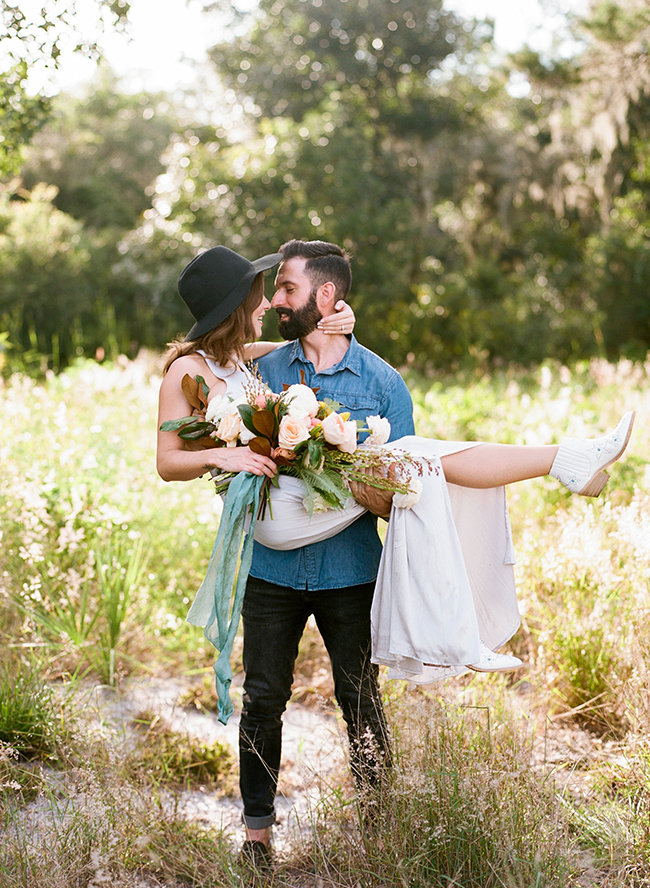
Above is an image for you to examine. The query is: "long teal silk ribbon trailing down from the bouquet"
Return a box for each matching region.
[187,472,264,725]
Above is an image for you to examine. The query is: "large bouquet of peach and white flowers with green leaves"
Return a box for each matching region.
[160,374,422,516]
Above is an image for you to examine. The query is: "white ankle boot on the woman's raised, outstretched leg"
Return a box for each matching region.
[549,411,634,496]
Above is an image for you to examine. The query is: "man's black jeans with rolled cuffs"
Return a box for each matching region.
[239,577,390,829]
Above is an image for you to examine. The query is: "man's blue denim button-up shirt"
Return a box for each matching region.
[250,337,414,590]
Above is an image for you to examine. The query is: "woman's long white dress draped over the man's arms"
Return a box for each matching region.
[196,356,520,683]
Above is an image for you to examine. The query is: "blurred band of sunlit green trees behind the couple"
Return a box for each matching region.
[0,0,650,371]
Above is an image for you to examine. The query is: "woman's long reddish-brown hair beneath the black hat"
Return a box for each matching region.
[163,273,264,376]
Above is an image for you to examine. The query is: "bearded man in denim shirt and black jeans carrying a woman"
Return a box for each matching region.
[239,240,414,865]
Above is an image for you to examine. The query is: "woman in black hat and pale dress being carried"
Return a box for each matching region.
[157,247,634,681]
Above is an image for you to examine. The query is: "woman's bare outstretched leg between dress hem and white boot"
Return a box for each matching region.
[440,444,558,488]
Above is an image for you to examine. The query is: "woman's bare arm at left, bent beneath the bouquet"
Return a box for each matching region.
[156,356,277,481]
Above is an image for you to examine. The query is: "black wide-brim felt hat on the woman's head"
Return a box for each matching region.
[178,247,282,341]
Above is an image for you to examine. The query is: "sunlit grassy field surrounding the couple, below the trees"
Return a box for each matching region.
[0,353,650,888]
